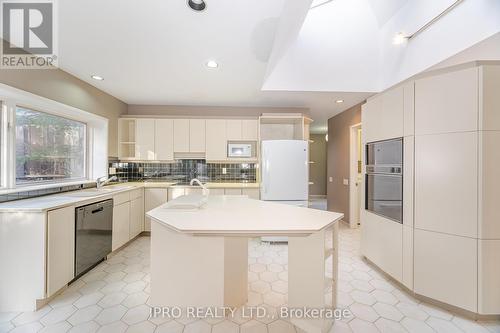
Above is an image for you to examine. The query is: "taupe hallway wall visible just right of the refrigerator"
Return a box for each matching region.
[309,134,326,195]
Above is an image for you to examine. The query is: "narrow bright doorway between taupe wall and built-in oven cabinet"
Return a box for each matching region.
[349,123,363,228]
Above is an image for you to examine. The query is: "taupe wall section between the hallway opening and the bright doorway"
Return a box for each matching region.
[327,104,361,222]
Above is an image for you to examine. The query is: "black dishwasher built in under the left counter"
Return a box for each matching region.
[75,199,113,279]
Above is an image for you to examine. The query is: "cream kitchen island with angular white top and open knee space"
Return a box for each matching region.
[147,195,343,332]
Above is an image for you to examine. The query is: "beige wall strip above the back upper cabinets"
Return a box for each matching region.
[128,105,309,117]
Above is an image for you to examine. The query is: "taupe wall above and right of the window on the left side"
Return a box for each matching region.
[0,69,127,156]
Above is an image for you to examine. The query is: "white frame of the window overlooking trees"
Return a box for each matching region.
[13,104,89,188]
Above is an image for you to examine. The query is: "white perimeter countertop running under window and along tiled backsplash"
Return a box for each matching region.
[0,181,259,213]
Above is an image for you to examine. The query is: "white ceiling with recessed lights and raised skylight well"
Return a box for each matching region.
[58,0,500,132]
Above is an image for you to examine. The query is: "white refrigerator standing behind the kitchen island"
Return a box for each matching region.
[260,140,309,242]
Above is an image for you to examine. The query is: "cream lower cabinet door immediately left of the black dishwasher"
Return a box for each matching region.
[46,206,75,296]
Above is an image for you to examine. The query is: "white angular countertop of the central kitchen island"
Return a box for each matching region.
[147,195,344,236]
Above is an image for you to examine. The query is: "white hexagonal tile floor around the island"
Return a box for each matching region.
[0,202,500,333]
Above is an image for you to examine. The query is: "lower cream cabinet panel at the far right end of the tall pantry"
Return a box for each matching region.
[478,239,500,315]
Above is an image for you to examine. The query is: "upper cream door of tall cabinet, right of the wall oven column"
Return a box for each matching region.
[415,67,479,135]
